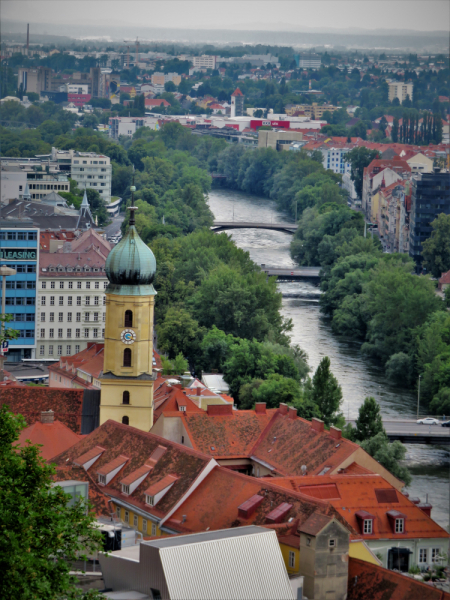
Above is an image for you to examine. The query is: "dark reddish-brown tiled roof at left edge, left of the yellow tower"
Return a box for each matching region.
[0,385,84,433]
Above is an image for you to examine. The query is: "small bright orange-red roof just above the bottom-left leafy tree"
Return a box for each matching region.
[18,421,80,460]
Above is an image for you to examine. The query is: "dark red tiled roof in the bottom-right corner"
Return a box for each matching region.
[347,557,450,600]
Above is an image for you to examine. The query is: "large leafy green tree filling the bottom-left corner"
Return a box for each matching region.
[0,406,101,600]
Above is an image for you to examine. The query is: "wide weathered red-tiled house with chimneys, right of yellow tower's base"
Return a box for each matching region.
[151,403,403,490]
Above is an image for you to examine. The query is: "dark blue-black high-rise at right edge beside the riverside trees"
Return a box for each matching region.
[409,168,450,271]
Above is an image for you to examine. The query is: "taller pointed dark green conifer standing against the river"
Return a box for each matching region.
[311,356,342,426]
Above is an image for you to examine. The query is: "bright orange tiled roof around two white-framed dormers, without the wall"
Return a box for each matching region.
[272,473,448,540]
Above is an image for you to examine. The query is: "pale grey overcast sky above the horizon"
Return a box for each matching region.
[1,0,450,34]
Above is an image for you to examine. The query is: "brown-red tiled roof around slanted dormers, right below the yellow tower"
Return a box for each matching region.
[54,420,211,517]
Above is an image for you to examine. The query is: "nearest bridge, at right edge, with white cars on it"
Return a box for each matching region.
[349,419,450,446]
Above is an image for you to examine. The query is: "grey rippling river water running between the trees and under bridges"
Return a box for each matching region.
[209,190,450,528]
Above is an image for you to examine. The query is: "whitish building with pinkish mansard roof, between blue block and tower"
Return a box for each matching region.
[37,229,111,360]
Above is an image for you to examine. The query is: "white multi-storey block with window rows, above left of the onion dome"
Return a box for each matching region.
[51,148,112,204]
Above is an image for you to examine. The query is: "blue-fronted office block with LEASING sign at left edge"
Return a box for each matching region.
[0,217,39,362]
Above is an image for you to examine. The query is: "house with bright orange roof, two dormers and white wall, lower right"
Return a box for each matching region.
[273,471,448,572]
